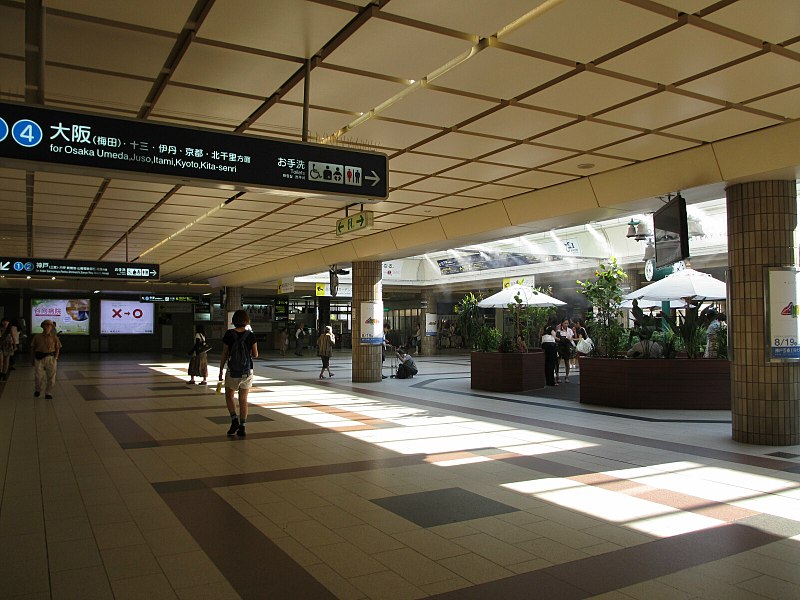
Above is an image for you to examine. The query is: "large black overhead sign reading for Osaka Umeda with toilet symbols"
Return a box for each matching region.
[0,102,389,202]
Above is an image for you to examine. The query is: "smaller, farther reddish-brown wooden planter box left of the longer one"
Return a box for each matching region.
[470,350,545,392]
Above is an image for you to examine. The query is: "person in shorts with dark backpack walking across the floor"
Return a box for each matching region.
[219,309,258,437]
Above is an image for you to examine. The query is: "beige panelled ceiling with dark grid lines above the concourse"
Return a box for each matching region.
[0,0,800,285]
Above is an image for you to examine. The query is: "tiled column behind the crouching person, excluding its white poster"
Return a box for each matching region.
[352,260,383,383]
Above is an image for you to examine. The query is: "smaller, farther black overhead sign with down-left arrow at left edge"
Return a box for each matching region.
[0,256,159,281]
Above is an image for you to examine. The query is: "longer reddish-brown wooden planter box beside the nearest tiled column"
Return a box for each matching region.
[578,357,731,410]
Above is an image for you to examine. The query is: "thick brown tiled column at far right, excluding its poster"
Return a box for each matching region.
[727,181,800,446]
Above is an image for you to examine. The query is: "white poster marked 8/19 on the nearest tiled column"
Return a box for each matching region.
[764,267,800,361]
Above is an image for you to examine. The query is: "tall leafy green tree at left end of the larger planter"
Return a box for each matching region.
[578,256,627,358]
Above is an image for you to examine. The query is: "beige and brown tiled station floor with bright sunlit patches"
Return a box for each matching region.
[0,354,800,600]
